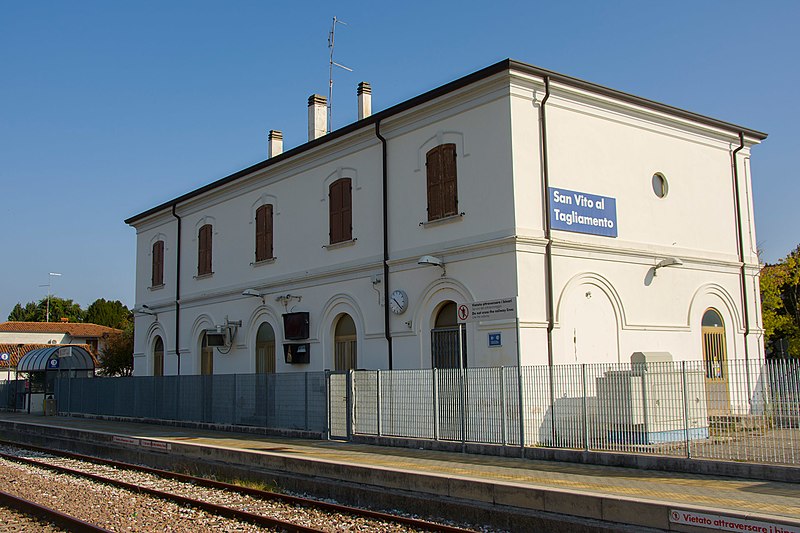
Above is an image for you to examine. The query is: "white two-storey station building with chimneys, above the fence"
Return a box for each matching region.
[126,60,766,375]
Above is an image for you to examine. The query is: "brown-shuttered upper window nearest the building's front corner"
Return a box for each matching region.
[425,143,458,221]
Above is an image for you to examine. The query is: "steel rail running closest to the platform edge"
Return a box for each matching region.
[0,439,470,533]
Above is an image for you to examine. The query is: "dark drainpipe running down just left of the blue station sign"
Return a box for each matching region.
[536,76,556,445]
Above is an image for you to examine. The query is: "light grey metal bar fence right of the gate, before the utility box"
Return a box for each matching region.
[349,360,800,464]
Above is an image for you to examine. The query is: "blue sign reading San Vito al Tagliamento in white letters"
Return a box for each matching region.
[548,187,617,237]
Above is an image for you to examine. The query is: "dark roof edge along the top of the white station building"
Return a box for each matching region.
[125,59,767,224]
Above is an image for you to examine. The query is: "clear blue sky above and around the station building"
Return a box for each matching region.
[0,0,800,320]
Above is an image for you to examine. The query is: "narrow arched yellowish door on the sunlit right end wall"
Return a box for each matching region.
[702,308,730,416]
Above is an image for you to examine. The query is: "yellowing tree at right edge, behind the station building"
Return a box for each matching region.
[761,245,800,357]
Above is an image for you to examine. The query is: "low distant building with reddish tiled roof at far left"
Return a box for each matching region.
[0,322,122,356]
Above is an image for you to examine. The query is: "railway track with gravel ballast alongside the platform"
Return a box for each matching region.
[0,441,470,533]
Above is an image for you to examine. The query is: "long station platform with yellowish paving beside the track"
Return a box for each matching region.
[0,412,800,533]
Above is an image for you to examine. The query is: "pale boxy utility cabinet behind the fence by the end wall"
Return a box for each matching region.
[597,352,708,444]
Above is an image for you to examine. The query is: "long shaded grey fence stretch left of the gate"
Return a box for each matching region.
[56,372,328,433]
